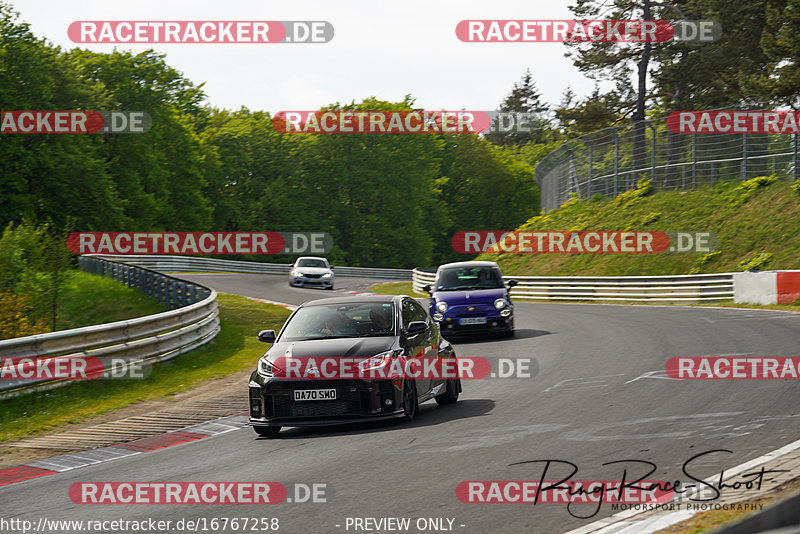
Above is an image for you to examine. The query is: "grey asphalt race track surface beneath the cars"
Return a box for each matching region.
[6,274,800,534]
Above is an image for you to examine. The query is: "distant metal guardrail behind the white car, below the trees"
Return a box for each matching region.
[92,254,411,280]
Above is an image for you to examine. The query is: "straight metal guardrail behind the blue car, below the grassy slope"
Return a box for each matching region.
[412,269,733,302]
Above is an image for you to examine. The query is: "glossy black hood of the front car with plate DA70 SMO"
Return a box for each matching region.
[266,336,396,362]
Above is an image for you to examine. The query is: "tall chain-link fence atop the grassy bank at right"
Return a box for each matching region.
[536,116,800,210]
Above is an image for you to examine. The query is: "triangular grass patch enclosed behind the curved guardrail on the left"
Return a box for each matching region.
[56,271,167,330]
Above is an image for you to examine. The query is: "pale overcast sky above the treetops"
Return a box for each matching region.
[11,0,594,113]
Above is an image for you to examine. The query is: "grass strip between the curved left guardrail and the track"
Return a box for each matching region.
[0,294,290,442]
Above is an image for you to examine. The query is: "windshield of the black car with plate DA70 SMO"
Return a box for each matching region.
[281,302,395,341]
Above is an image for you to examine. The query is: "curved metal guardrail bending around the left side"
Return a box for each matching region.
[0,256,220,397]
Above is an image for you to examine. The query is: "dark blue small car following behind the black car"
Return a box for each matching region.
[422,261,517,337]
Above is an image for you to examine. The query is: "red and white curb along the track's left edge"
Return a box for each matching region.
[0,415,247,486]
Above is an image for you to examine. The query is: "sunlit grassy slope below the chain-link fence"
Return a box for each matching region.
[478,179,800,276]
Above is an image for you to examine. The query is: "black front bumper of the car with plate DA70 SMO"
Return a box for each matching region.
[249,376,403,426]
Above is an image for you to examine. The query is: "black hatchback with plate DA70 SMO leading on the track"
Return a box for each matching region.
[250,295,461,436]
